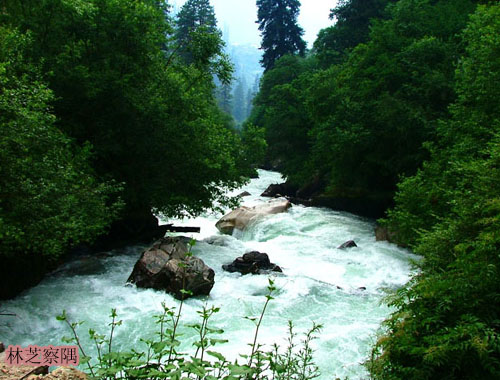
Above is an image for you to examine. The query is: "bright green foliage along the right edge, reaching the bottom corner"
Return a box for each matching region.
[368,3,500,380]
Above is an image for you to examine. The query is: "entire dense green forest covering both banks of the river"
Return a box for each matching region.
[0,0,500,380]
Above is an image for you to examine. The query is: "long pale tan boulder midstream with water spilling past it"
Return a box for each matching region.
[215,198,291,235]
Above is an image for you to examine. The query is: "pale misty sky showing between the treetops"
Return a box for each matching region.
[171,0,337,47]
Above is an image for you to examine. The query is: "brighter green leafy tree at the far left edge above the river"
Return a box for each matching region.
[0,27,120,299]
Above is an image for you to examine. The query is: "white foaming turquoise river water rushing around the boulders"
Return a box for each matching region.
[0,171,415,379]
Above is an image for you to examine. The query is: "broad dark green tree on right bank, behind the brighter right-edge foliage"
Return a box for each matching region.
[308,0,476,208]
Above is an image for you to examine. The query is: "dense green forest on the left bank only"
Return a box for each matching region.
[0,0,262,297]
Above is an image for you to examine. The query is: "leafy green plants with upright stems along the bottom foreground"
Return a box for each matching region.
[57,279,321,380]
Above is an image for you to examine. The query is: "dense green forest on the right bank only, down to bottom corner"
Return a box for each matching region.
[249,0,500,380]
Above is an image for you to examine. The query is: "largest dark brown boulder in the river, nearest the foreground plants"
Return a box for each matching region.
[127,237,215,299]
